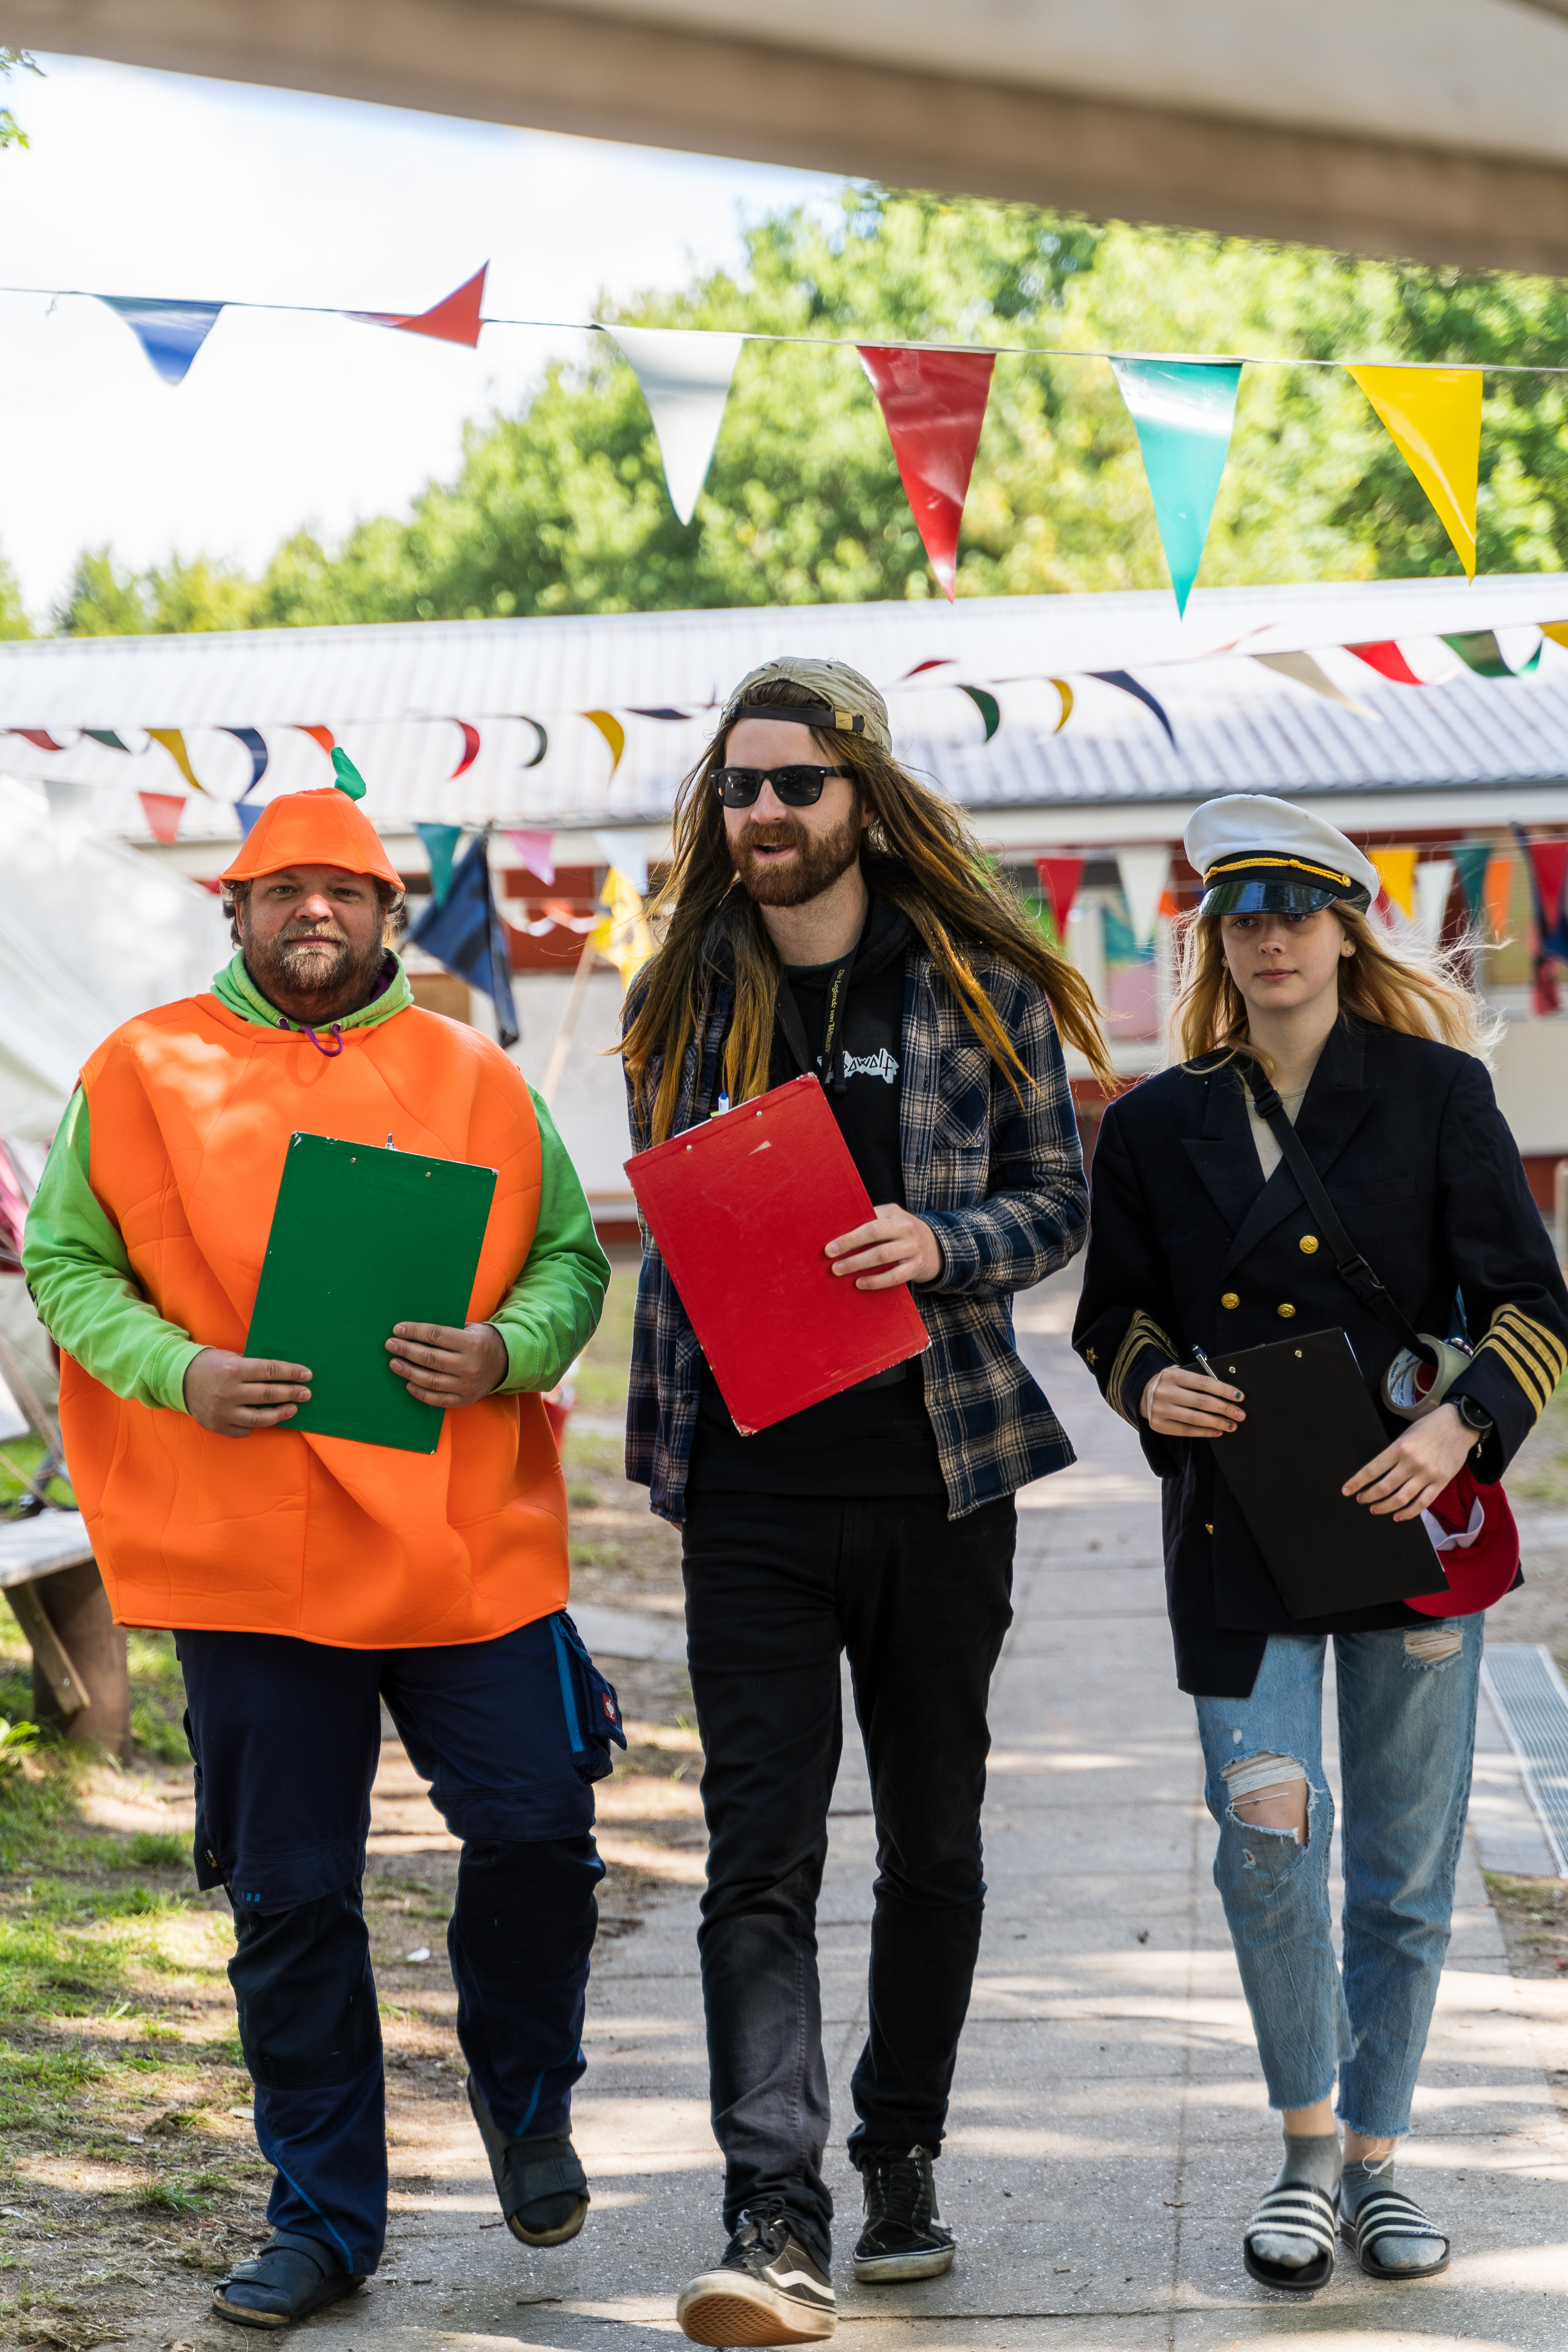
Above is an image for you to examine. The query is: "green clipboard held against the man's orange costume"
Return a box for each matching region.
[244,1134,496,1453]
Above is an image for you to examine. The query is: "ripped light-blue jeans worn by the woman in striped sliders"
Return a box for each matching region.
[1196,1616,1486,2140]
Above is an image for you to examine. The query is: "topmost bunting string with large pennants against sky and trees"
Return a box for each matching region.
[0,263,1568,614]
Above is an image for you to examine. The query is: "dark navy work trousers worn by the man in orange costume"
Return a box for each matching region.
[176,1618,618,2272]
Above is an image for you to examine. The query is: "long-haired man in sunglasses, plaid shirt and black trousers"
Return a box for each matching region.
[623,661,1105,2345]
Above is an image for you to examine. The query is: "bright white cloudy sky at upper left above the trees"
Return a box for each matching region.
[0,56,837,616]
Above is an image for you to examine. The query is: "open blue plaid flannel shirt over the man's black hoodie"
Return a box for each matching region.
[625,927,1088,1526]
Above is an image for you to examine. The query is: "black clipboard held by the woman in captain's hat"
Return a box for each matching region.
[1208,1331,1448,1618]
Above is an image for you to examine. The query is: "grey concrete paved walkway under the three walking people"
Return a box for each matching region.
[355,1287,1568,2352]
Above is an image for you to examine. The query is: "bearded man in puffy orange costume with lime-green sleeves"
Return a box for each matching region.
[23,755,620,2329]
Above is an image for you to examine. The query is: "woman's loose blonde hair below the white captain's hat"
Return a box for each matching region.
[1171,903,1498,1077]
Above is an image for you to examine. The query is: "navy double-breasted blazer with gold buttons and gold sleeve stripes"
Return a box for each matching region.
[1072,1016,1568,1698]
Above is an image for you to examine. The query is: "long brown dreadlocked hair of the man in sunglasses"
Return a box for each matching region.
[620,677,1117,1143]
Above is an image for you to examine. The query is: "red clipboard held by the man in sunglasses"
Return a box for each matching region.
[625,1077,931,1437]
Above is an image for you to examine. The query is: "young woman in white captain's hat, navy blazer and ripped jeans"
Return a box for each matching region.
[1074,795,1568,2293]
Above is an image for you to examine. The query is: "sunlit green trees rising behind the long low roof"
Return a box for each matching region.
[61,188,1568,628]
